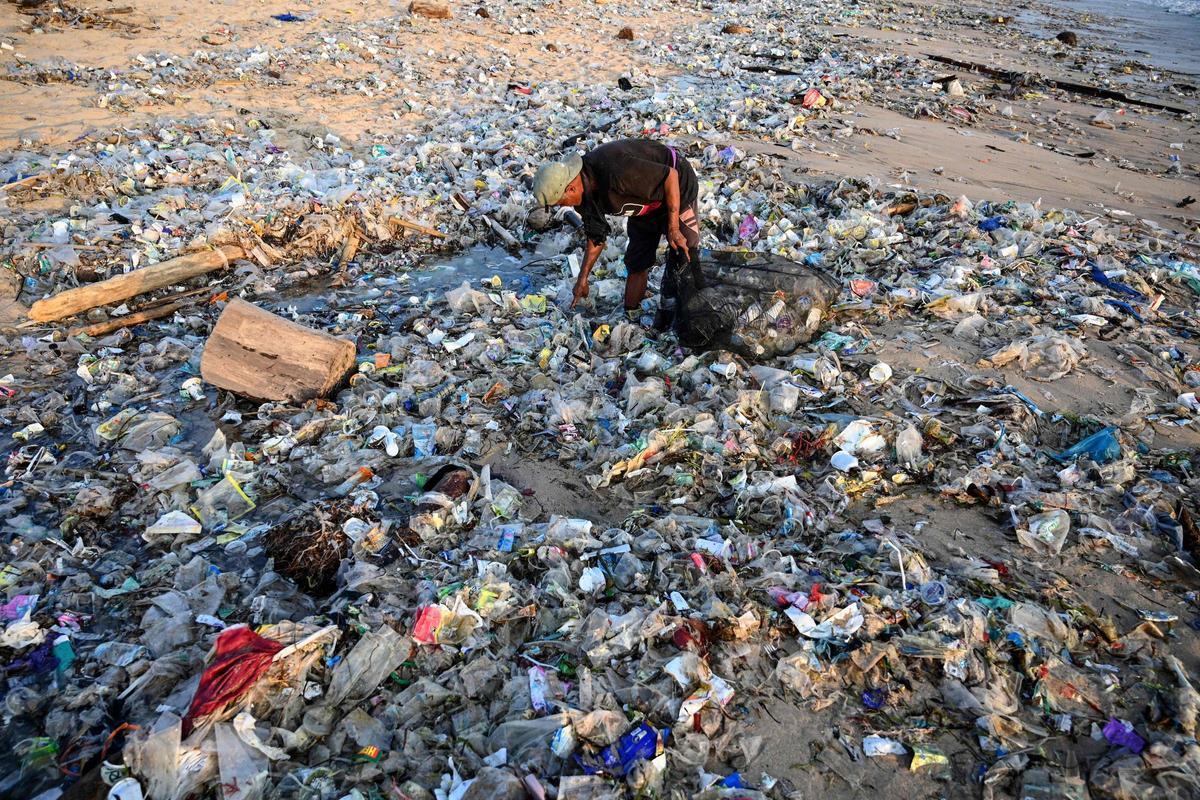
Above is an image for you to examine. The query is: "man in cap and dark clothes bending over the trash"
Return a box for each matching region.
[533,139,700,327]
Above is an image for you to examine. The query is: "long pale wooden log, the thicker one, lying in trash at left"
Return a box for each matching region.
[29,245,246,323]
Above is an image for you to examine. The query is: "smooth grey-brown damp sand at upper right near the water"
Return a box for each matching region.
[772,2,1200,234]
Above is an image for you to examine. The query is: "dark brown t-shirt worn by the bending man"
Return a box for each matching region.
[578,139,697,245]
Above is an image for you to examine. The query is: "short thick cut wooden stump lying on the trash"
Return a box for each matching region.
[200,299,354,402]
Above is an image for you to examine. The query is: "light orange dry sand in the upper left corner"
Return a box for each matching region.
[0,0,665,149]
